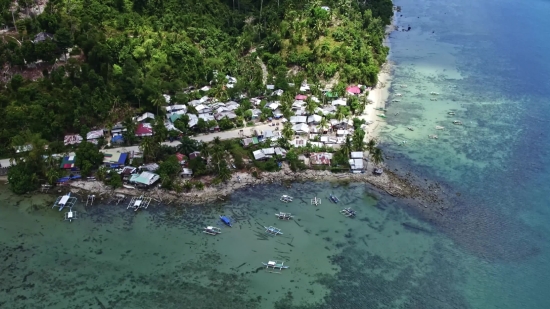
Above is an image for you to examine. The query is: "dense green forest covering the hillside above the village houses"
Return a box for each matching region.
[0,0,393,153]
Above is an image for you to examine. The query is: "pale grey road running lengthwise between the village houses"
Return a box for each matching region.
[0,123,281,167]
